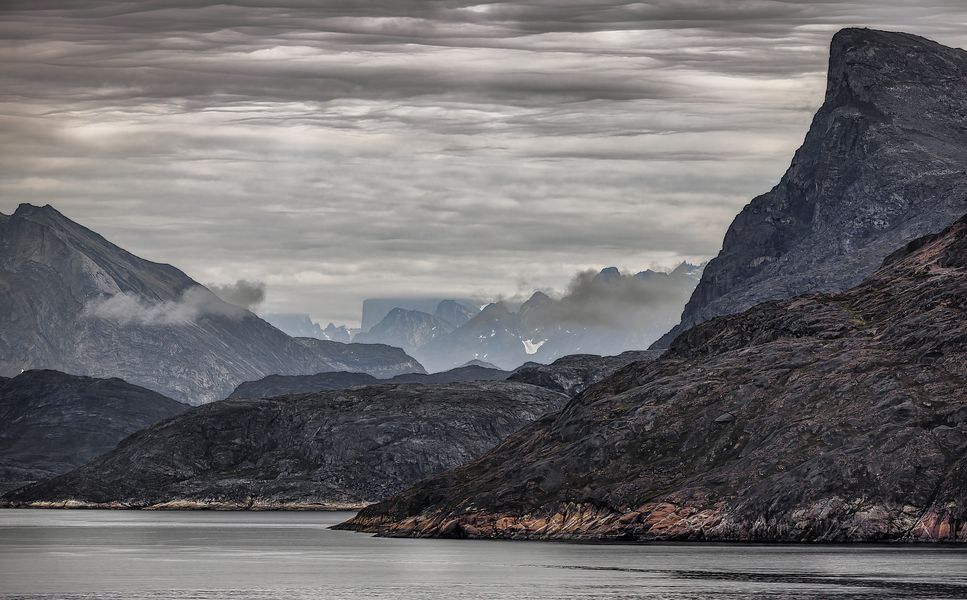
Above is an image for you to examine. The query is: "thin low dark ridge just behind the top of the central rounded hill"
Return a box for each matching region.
[228,365,516,400]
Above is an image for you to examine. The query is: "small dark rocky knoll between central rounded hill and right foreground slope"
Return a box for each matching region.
[507,350,662,397]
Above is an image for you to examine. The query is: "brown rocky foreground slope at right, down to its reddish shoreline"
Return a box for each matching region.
[345,217,967,542]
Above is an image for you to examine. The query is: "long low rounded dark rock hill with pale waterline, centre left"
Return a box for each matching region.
[4,382,567,508]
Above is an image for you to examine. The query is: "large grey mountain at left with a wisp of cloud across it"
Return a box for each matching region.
[0,204,423,404]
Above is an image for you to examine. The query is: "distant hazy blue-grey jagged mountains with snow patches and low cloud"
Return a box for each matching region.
[263,263,704,372]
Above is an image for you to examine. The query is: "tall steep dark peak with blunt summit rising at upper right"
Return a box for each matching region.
[656,29,967,347]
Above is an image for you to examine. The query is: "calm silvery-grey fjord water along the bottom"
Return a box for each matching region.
[0,510,967,600]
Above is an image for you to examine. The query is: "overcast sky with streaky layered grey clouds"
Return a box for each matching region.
[0,0,967,325]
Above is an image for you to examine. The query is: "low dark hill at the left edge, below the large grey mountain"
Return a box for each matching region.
[0,371,188,491]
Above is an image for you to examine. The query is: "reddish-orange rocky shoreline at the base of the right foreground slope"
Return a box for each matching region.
[342,499,967,544]
